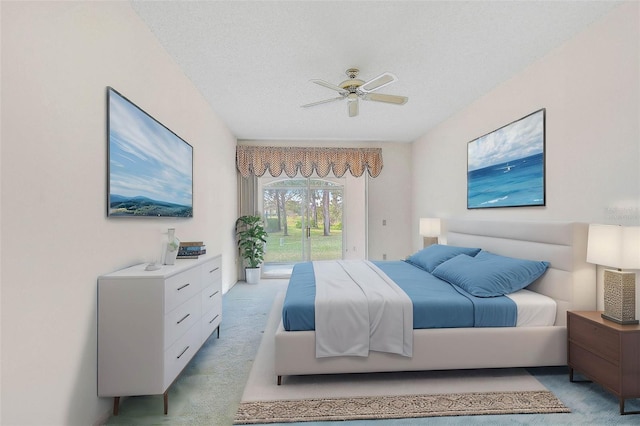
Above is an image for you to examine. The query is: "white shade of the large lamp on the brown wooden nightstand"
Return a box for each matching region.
[587,225,640,269]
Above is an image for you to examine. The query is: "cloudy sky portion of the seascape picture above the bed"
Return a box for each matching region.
[467,110,544,171]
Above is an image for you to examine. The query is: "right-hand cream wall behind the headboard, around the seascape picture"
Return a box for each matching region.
[412,2,640,314]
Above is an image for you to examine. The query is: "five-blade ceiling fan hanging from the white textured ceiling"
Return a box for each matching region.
[302,68,409,117]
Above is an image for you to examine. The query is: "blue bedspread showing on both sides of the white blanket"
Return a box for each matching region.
[282,261,517,331]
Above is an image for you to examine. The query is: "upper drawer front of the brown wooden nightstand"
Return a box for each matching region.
[569,315,620,364]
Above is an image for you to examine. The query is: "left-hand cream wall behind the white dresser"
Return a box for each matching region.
[0,2,237,425]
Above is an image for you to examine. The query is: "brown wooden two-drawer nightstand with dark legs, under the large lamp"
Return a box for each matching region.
[567,311,640,414]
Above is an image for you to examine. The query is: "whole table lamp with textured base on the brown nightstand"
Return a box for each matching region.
[587,225,640,324]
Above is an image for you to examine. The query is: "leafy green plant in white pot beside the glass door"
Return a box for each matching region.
[236,215,268,284]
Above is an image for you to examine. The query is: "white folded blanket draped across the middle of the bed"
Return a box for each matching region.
[313,260,413,358]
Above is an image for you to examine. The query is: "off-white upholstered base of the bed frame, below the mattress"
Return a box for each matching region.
[275,324,567,385]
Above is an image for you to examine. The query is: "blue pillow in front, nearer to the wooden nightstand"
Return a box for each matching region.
[433,250,549,297]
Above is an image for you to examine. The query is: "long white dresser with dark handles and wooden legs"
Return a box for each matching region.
[98,255,222,415]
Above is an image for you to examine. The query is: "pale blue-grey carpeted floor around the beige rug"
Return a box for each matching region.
[106,280,640,426]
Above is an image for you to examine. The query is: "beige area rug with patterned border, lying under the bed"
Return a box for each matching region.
[234,295,570,424]
